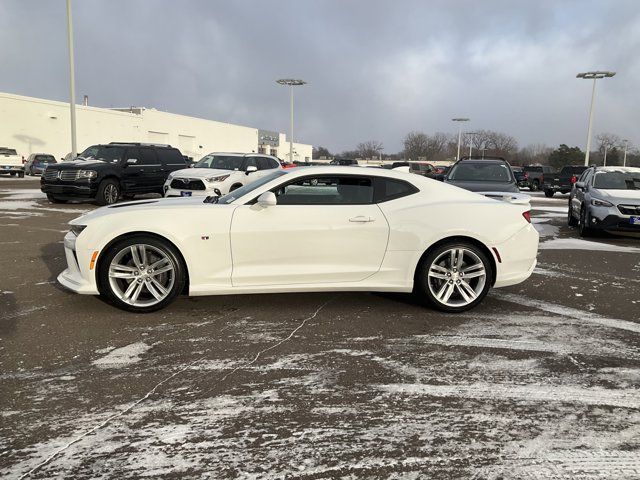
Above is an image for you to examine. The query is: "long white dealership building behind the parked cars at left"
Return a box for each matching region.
[0,92,312,162]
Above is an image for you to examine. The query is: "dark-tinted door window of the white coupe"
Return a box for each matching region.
[274,176,373,205]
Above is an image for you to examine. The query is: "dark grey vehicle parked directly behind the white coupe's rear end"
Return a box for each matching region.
[444,157,520,193]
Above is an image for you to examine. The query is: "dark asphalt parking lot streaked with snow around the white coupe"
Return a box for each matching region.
[0,178,640,479]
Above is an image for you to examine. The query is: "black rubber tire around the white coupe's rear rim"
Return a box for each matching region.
[414,241,493,313]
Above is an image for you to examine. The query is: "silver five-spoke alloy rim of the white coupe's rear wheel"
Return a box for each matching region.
[427,247,487,307]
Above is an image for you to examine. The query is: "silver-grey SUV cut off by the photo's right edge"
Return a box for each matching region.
[567,167,640,237]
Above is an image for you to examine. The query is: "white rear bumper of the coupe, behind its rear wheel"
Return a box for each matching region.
[494,224,539,288]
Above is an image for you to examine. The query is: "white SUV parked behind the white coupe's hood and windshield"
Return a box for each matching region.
[164,153,282,197]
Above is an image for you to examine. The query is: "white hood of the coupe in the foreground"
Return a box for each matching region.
[69,197,225,225]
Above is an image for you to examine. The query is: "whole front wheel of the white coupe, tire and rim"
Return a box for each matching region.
[98,235,186,313]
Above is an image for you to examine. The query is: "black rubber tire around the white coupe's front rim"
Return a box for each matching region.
[98,235,187,313]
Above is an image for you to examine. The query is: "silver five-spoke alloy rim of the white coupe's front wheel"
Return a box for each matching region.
[109,244,176,307]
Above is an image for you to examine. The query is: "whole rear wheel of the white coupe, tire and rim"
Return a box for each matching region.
[416,242,493,313]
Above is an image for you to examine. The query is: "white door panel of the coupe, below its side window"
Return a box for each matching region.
[231,204,389,286]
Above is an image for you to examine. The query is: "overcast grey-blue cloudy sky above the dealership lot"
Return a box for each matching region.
[0,0,640,153]
